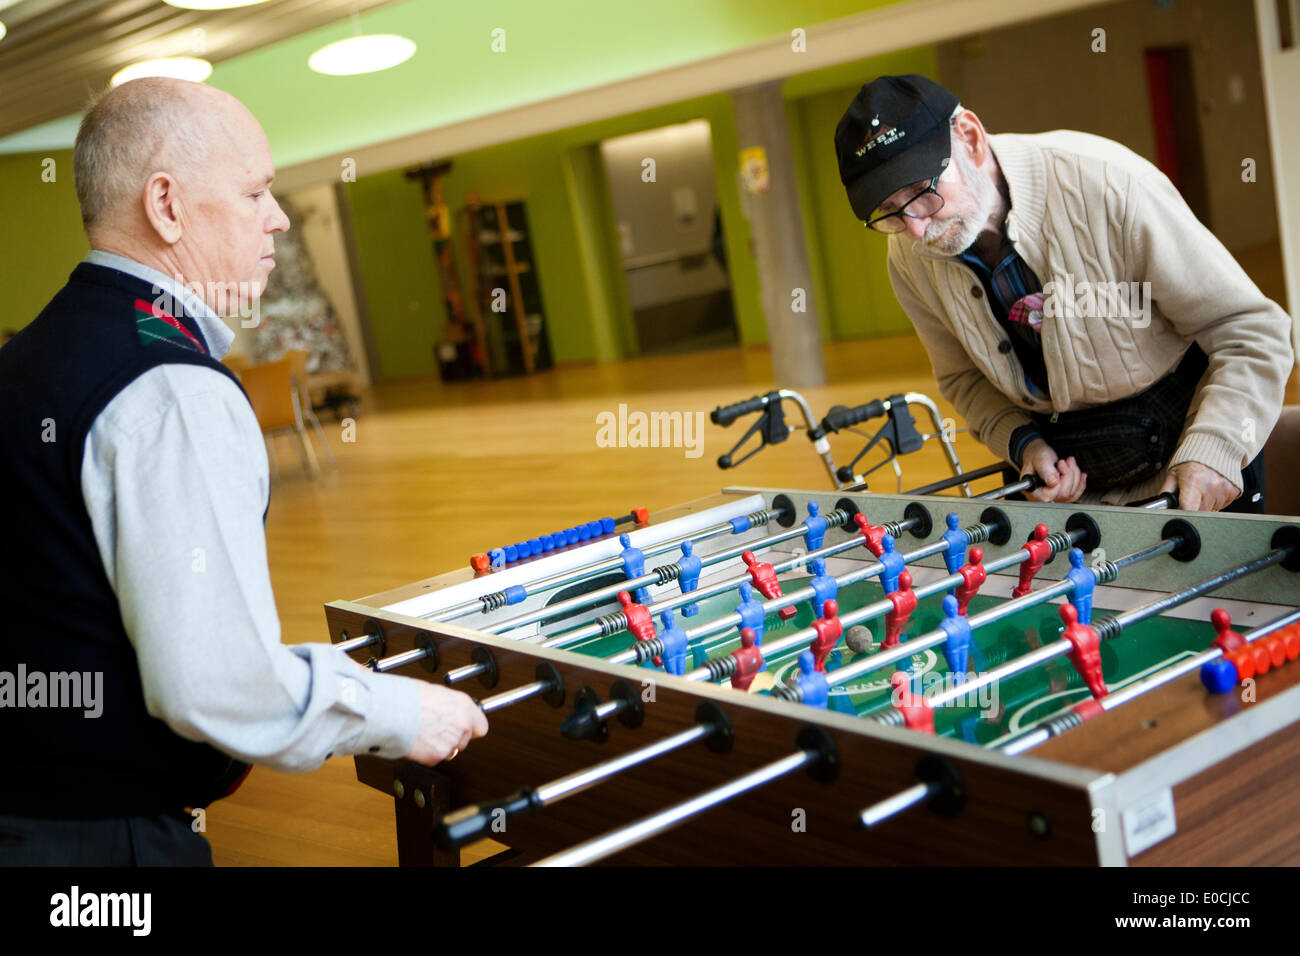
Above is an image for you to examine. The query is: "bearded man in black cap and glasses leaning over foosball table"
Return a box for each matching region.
[835,75,1294,511]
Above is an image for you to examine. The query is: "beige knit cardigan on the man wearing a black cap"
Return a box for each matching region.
[888,130,1294,503]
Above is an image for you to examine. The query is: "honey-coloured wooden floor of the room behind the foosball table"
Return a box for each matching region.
[207,336,1300,865]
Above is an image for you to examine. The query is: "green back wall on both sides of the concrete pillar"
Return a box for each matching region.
[351,47,933,377]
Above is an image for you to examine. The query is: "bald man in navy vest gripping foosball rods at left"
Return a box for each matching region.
[0,79,488,865]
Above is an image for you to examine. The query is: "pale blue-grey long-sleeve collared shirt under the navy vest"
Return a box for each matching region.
[82,250,420,771]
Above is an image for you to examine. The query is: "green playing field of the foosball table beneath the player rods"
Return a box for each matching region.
[543,578,1214,744]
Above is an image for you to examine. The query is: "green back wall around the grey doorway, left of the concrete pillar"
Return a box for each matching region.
[351,94,767,377]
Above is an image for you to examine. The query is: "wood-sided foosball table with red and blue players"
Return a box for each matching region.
[325,488,1300,866]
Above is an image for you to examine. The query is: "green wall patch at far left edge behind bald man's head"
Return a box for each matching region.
[0,150,90,329]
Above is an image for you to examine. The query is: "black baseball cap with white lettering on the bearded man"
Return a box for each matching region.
[835,73,959,221]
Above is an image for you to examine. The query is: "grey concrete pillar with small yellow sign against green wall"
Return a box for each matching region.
[732,81,826,389]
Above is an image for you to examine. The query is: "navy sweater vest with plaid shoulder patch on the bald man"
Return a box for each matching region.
[0,263,256,818]
